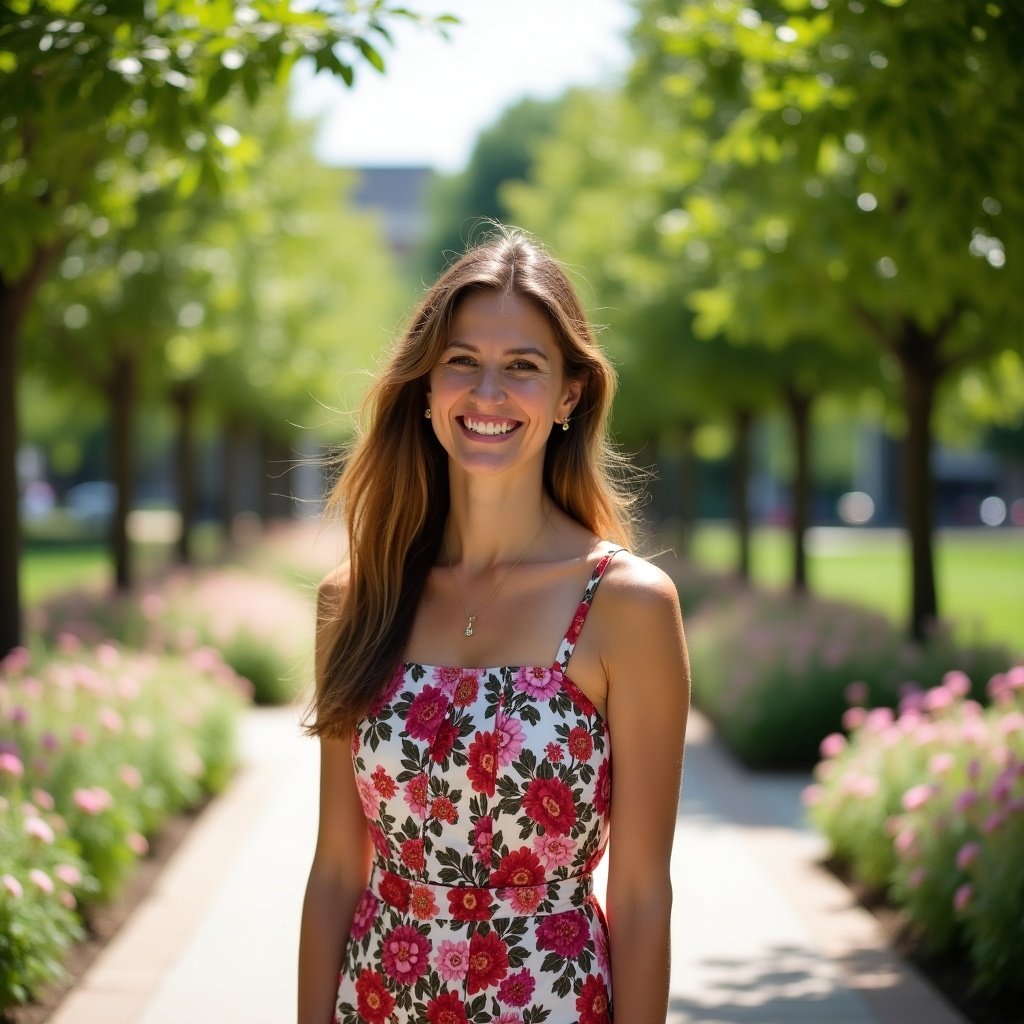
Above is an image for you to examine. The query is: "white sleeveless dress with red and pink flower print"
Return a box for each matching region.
[335,548,621,1024]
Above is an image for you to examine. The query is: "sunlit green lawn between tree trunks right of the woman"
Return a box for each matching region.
[693,523,1024,652]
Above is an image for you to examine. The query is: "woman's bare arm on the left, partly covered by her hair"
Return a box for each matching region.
[298,578,373,1024]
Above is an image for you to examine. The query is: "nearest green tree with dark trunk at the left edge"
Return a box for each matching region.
[0,0,440,650]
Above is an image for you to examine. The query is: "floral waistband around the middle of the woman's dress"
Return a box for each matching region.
[370,861,594,921]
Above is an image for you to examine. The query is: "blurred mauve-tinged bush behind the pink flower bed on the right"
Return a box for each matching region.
[687,591,1012,768]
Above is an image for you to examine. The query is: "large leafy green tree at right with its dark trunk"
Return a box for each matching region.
[635,0,1024,638]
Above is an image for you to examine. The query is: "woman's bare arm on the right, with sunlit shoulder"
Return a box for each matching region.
[601,556,690,1024]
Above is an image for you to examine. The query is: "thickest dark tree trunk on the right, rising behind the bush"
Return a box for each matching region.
[898,323,940,641]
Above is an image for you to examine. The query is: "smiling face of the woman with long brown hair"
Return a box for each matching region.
[428,291,581,474]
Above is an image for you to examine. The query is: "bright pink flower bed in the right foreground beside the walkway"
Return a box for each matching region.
[805,666,1024,993]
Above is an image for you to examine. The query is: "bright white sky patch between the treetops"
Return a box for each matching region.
[293,0,633,173]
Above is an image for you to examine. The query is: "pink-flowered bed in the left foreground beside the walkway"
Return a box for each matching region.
[0,635,251,1012]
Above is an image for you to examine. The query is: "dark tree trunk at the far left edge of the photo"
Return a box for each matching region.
[0,246,60,657]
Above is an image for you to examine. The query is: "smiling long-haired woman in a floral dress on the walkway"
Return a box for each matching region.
[299,230,689,1024]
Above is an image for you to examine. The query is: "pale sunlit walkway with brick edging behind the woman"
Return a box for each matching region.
[44,709,964,1024]
